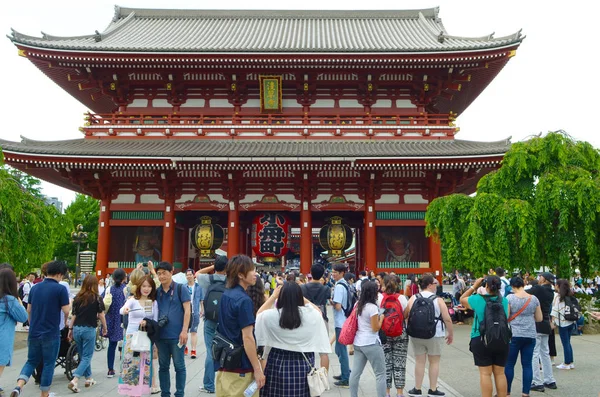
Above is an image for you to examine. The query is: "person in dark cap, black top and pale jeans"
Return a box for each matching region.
[526,272,556,392]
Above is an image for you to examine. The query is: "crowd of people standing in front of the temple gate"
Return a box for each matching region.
[0,255,600,397]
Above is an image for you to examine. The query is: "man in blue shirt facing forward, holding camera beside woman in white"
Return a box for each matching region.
[155,262,191,397]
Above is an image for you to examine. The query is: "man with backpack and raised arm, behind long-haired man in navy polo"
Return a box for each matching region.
[196,255,227,394]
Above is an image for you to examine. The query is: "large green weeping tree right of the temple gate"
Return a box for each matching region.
[425,131,600,277]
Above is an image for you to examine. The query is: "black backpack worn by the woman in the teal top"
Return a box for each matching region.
[479,296,512,352]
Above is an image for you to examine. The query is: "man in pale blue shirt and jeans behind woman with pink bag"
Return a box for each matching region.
[331,263,350,388]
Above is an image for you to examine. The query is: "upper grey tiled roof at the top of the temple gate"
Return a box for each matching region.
[10,7,523,53]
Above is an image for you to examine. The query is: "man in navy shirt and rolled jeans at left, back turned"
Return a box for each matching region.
[10,261,70,397]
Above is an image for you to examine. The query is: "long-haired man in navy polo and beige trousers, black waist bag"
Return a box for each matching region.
[215,255,265,397]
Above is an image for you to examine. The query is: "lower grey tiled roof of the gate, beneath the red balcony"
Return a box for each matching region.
[0,138,510,161]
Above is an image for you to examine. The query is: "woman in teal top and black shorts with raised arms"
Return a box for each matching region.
[460,276,509,397]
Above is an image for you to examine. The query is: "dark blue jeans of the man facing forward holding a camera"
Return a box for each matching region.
[156,339,186,397]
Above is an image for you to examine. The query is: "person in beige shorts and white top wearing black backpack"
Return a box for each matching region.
[404,274,454,397]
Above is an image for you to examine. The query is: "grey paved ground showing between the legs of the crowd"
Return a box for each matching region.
[5,296,600,397]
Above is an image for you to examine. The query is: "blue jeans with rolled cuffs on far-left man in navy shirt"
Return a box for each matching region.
[18,338,60,391]
